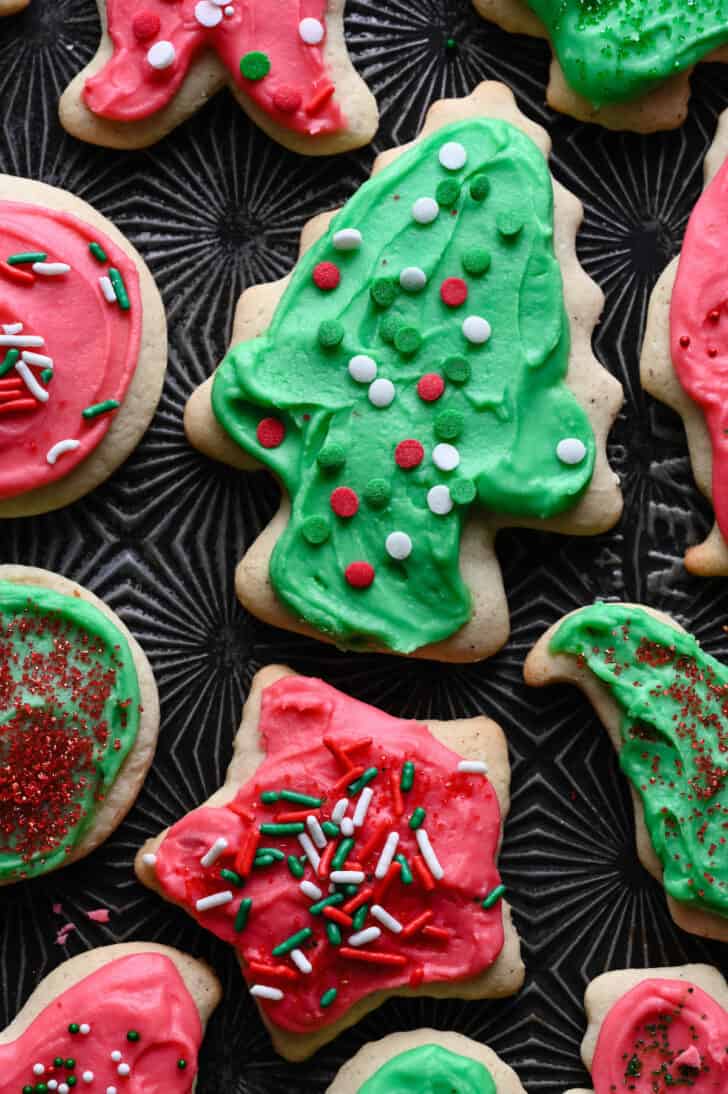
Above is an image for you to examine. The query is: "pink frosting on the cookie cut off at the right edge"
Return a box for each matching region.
[670,161,728,540]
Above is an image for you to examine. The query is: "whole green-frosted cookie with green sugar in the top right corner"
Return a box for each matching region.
[474,0,728,132]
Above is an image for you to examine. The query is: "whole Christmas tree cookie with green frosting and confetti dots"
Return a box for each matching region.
[186,84,621,661]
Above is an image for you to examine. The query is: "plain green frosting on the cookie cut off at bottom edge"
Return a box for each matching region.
[359,1045,496,1094]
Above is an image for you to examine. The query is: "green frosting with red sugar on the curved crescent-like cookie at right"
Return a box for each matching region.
[550,604,728,916]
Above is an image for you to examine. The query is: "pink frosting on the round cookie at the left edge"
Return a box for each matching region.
[0,201,141,498]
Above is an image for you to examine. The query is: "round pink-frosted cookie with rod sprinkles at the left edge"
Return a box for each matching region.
[0,175,166,517]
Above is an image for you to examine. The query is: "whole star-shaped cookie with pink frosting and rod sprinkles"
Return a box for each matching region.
[136,666,523,1060]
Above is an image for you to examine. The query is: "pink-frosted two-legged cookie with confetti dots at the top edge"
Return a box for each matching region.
[60,0,378,155]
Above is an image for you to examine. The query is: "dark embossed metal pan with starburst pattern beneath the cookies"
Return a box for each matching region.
[0,0,728,1094]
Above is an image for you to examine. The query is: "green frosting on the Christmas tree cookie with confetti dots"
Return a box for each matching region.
[212,118,594,653]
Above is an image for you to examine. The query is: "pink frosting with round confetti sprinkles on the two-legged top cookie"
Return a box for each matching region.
[83,0,346,137]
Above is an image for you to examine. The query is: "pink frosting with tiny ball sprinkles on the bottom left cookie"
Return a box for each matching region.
[0,953,203,1094]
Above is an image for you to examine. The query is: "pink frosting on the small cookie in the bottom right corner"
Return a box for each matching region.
[591,978,728,1094]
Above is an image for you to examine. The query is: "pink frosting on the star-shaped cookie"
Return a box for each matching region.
[157,677,504,1033]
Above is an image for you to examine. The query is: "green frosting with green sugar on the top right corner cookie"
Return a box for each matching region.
[527,0,728,106]
